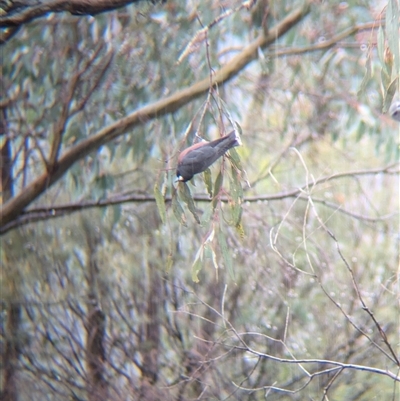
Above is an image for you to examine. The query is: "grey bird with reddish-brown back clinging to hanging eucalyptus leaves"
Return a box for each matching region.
[176,131,242,182]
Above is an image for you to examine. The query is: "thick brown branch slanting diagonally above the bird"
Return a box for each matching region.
[0,1,310,227]
